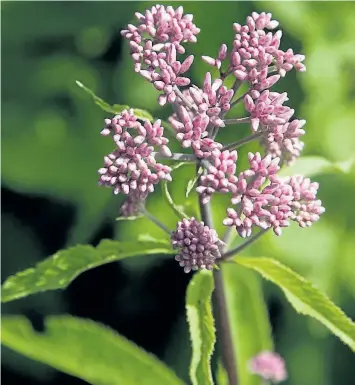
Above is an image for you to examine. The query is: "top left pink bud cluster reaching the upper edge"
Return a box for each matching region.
[121,5,200,106]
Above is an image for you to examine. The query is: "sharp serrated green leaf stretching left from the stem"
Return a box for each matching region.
[1,240,172,302]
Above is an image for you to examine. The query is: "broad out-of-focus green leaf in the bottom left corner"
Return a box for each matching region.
[1,316,183,385]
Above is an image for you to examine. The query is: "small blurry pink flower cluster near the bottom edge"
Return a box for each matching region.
[249,352,287,384]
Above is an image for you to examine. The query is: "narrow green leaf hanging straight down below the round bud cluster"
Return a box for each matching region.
[186,270,216,385]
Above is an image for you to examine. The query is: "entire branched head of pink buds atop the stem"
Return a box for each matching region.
[99,5,324,272]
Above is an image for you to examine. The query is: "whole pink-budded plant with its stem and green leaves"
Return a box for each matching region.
[2,5,355,385]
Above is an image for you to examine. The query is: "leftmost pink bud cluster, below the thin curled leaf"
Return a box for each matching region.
[99,110,171,198]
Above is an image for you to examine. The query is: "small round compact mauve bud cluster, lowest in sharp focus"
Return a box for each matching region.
[171,217,223,273]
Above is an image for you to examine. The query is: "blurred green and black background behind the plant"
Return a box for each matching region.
[1,1,355,385]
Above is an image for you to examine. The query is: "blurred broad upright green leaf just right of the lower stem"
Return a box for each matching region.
[221,263,273,385]
